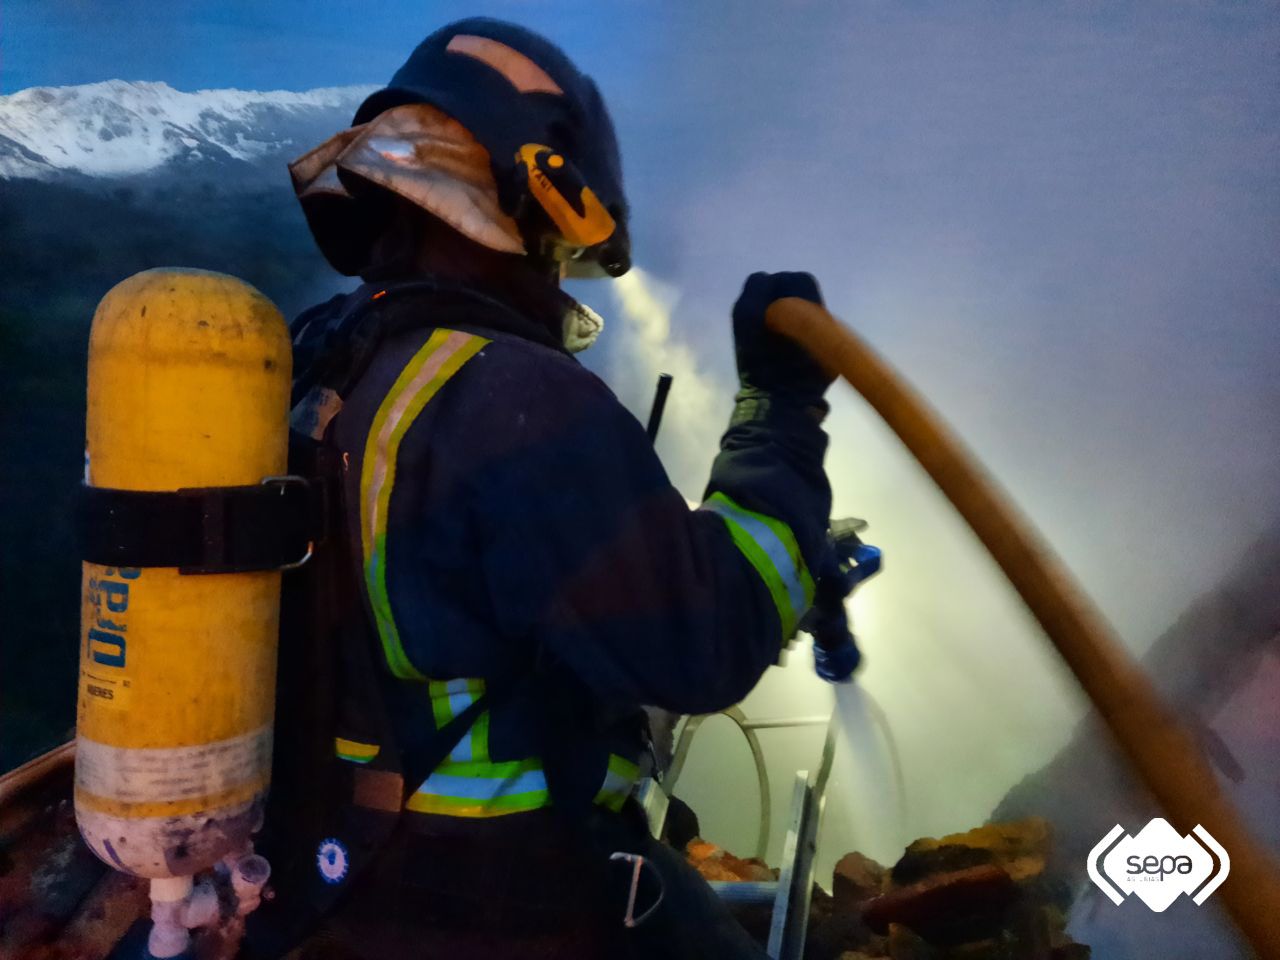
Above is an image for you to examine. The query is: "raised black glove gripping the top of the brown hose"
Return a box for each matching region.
[733,273,833,406]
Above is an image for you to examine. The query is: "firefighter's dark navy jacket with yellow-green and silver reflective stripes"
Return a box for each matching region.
[286,277,831,822]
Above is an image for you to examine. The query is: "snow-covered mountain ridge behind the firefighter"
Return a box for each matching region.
[0,81,374,179]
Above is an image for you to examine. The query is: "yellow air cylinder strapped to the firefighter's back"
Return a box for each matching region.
[76,269,291,897]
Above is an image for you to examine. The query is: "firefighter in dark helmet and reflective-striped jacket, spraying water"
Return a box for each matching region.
[268,19,831,957]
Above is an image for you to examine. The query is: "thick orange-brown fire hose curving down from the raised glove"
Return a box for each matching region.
[765,297,1280,957]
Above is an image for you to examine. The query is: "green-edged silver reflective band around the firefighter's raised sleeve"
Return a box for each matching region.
[700,493,814,643]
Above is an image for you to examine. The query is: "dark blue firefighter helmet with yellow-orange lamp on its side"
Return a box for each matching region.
[352,17,631,276]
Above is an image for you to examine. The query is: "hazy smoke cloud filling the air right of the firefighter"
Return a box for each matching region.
[588,9,1280,916]
